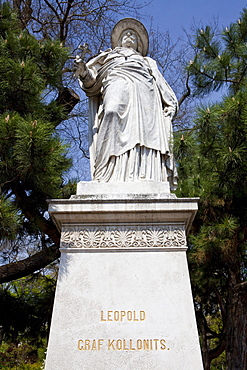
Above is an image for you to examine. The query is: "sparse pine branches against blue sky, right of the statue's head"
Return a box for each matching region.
[188,9,247,96]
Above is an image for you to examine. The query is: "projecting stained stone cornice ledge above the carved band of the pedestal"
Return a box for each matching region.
[48,194,198,232]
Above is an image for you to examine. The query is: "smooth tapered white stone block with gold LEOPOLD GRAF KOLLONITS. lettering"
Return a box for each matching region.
[46,251,202,370]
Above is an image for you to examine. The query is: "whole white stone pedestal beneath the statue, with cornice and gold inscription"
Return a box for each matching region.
[45,183,203,370]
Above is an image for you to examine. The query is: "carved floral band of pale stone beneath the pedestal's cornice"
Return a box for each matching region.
[61,225,186,248]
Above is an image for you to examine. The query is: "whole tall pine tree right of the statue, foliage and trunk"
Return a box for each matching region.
[177,9,247,370]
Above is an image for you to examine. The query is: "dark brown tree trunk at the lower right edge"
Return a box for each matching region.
[226,277,247,370]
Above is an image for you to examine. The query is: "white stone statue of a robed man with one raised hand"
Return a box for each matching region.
[76,18,178,190]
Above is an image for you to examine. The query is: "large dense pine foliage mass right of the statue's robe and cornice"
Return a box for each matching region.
[177,91,247,284]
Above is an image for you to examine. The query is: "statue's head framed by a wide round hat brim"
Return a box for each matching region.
[111,18,148,56]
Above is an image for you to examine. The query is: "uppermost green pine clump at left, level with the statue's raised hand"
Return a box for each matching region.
[0,3,68,116]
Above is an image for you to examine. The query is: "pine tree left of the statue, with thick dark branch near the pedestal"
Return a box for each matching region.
[0,3,78,282]
